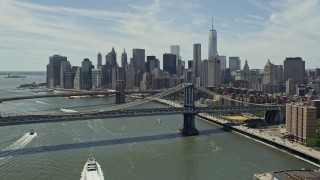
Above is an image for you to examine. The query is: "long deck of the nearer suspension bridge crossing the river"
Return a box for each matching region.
[0,106,278,126]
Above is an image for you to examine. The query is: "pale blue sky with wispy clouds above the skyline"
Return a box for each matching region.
[0,0,320,71]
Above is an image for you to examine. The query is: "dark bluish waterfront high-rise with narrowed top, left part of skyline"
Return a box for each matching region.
[81,58,92,90]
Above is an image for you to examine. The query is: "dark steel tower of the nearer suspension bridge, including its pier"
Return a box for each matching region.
[182,83,199,136]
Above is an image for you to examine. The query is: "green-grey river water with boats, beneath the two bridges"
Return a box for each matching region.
[0,75,316,180]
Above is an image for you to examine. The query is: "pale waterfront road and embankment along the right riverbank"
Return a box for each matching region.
[156,98,320,168]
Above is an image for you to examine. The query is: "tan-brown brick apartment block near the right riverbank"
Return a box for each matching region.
[286,104,317,142]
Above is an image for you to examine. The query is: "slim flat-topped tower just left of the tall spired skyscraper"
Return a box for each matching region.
[192,44,201,84]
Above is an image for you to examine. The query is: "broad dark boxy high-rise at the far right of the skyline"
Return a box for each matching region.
[283,57,305,84]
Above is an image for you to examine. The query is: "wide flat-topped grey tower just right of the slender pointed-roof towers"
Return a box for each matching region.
[130,49,146,72]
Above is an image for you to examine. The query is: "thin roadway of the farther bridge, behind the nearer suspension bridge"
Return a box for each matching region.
[0,90,161,103]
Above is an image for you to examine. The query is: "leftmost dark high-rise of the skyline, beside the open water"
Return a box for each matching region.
[47,55,67,88]
